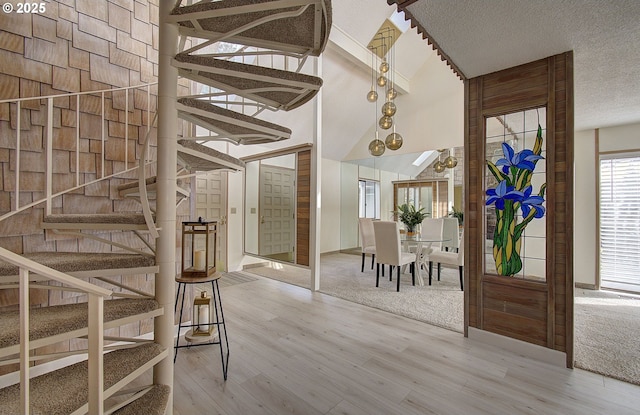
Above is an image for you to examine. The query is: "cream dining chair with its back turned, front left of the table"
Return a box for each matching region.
[373,221,416,291]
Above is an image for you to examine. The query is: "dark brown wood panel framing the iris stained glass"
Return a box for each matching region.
[465,52,573,367]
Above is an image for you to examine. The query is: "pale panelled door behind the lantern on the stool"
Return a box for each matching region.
[195,172,228,271]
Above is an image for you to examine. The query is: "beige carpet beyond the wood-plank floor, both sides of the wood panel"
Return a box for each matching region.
[246,254,640,385]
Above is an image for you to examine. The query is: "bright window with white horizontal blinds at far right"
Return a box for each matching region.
[600,153,640,292]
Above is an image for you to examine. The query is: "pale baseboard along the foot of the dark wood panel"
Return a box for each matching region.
[468,327,567,367]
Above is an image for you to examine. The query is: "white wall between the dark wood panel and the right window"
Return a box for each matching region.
[573,124,640,287]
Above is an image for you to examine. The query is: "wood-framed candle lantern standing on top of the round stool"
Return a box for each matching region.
[182,218,218,278]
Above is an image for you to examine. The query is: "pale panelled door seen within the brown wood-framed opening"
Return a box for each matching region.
[259,164,296,261]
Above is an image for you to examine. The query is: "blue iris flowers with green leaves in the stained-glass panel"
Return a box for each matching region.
[486,125,547,276]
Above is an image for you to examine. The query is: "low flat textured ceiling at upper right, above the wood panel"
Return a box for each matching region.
[407,0,640,130]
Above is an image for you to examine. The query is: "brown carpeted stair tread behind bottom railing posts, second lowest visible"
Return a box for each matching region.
[0,343,163,415]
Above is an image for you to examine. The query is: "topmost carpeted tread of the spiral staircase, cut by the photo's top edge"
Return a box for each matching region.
[171,0,332,56]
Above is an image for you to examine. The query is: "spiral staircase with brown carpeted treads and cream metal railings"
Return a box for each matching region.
[0,0,331,414]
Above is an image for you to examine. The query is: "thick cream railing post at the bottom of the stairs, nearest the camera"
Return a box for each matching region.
[88,294,104,415]
